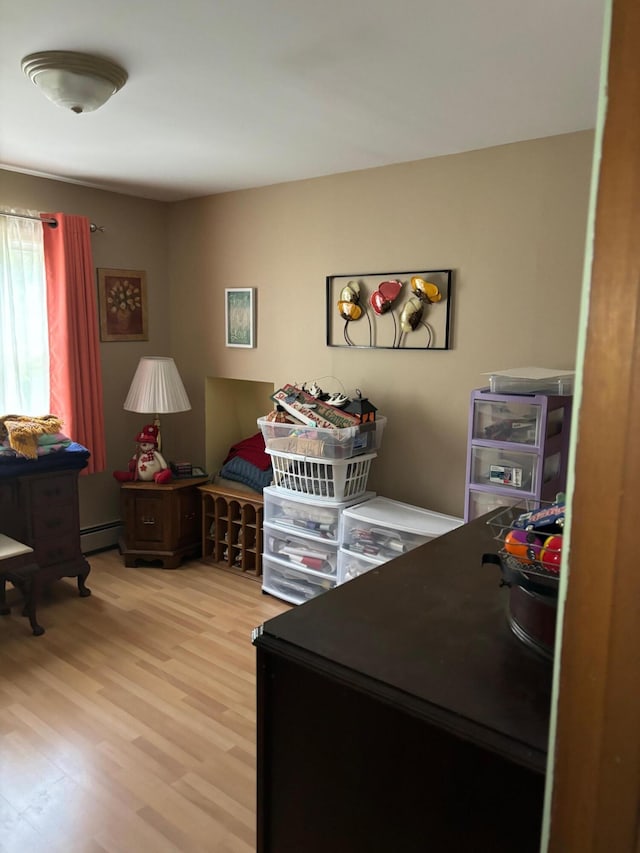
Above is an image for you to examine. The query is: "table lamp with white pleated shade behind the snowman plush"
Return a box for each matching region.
[124,355,191,451]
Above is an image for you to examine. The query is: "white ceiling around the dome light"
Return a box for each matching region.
[0,0,604,201]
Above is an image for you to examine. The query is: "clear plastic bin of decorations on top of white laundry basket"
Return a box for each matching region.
[258,416,387,459]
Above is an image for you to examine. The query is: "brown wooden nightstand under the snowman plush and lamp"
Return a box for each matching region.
[119,477,208,569]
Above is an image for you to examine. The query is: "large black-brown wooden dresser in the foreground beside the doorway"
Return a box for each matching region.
[254,516,552,853]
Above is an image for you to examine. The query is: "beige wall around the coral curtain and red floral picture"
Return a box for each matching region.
[0,171,170,528]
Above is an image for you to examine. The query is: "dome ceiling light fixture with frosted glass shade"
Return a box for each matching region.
[22,50,128,113]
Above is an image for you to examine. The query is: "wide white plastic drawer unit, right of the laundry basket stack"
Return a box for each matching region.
[338,497,463,583]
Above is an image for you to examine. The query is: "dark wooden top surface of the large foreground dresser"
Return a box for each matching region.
[256,516,552,773]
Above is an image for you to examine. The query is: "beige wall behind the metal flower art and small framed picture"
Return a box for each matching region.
[170,131,593,515]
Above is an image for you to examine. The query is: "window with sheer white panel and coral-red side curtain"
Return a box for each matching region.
[0,210,106,473]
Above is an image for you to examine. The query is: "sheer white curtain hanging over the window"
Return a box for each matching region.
[0,208,49,416]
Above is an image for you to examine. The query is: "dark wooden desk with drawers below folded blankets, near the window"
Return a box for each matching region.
[0,445,91,597]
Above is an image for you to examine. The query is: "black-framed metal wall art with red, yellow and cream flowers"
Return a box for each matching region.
[327,270,452,350]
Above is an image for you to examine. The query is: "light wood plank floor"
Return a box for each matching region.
[0,550,289,853]
